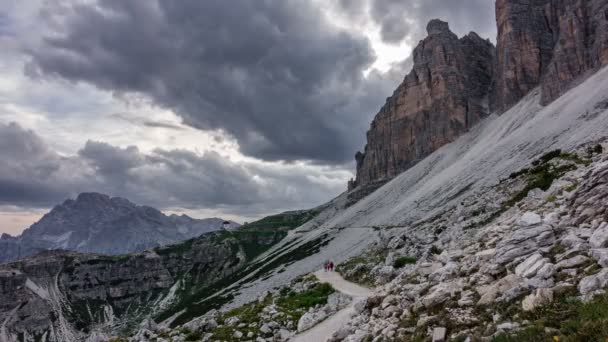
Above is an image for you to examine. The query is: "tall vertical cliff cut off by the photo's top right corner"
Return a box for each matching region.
[495,0,608,111]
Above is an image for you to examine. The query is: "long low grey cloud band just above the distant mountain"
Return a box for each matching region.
[0,123,346,215]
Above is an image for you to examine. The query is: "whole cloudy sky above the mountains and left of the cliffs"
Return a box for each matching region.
[0,0,496,235]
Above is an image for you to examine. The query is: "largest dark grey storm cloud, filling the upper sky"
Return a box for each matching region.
[27,0,394,163]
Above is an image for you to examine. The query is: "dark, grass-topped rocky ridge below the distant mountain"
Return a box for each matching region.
[0,226,286,342]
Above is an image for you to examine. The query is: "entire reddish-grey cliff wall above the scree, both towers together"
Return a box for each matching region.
[349,0,608,187]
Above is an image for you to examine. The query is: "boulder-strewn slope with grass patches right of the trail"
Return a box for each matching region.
[333,145,608,341]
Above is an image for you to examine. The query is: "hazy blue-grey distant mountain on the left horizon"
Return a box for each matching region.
[0,193,239,262]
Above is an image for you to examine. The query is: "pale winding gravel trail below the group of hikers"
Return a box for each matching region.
[290,271,374,342]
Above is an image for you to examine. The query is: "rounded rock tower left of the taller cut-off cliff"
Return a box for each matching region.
[354,20,495,186]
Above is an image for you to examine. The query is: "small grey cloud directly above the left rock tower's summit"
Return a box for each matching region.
[338,0,496,43]
